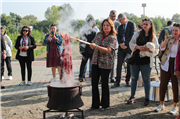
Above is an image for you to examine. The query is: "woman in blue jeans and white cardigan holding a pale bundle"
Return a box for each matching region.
[127,19,159,106]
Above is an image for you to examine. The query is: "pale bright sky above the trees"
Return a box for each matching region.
[0,0,180,21]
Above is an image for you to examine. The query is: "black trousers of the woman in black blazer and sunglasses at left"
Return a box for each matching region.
[19,56,32,81]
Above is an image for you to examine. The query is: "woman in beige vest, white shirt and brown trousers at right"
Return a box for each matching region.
[155,23,180,115]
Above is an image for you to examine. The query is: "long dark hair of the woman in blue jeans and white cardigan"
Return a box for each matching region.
[138,19,156,42]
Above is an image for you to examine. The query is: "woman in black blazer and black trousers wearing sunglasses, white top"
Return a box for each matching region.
[15,26,36,86]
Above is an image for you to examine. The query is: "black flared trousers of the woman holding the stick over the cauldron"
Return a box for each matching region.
[91,65,111,108]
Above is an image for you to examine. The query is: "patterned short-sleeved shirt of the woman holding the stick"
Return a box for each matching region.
[92,33,117,69]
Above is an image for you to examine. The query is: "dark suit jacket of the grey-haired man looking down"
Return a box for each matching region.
[117,21,136,53]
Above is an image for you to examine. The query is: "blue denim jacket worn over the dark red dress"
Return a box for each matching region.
[44,34,63,54]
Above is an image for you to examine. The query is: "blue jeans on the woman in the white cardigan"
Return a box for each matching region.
[130,64,152,99]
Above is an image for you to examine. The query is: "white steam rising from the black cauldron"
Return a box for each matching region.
[50,7,94,87]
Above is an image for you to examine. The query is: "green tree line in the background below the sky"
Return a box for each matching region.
[0,4,180,33]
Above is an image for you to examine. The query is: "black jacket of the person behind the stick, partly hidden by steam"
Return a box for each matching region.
[79,30,96,55]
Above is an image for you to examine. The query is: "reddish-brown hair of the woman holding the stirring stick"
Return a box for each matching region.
[100,19,116,37]
